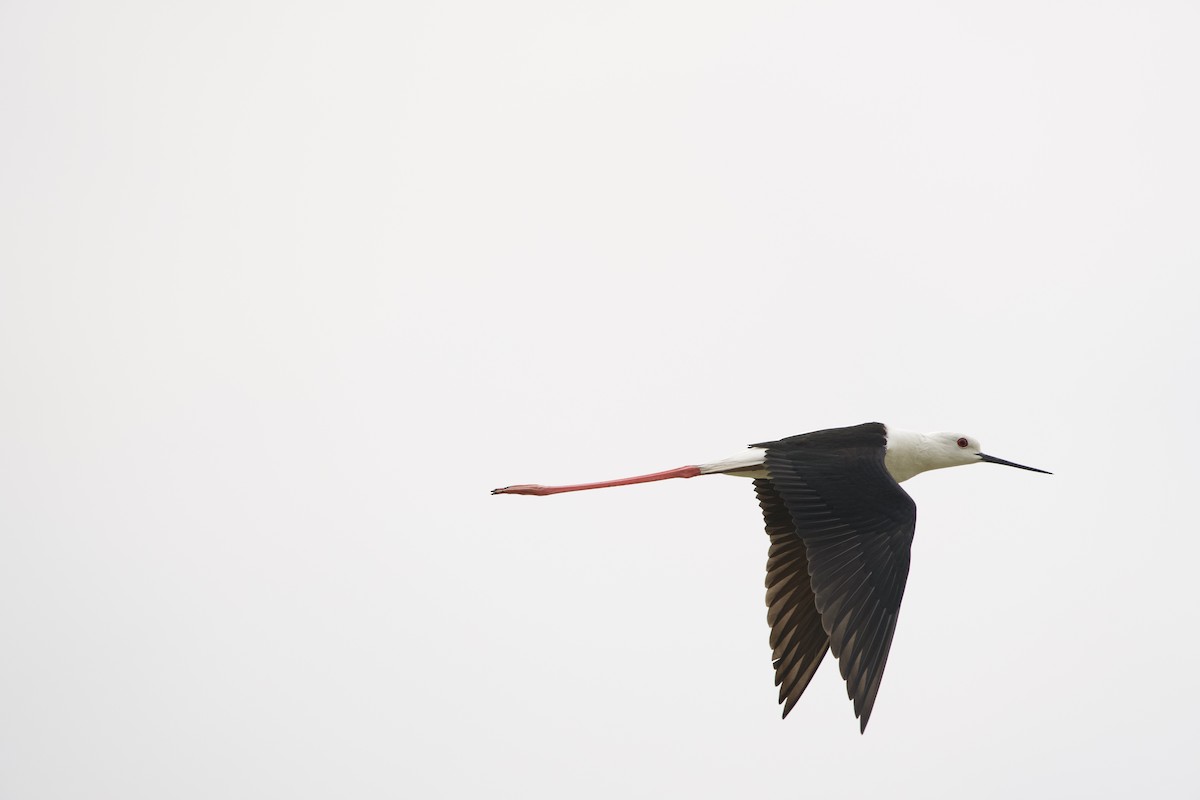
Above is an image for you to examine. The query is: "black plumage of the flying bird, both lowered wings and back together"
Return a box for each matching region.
[755,423,917,730]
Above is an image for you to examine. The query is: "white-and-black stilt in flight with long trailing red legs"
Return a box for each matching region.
[492,422,1051,733]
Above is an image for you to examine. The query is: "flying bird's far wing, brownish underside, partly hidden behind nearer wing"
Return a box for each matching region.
[754,479,829,717]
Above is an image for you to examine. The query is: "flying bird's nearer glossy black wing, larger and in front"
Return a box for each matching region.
[755,422,917,730]
